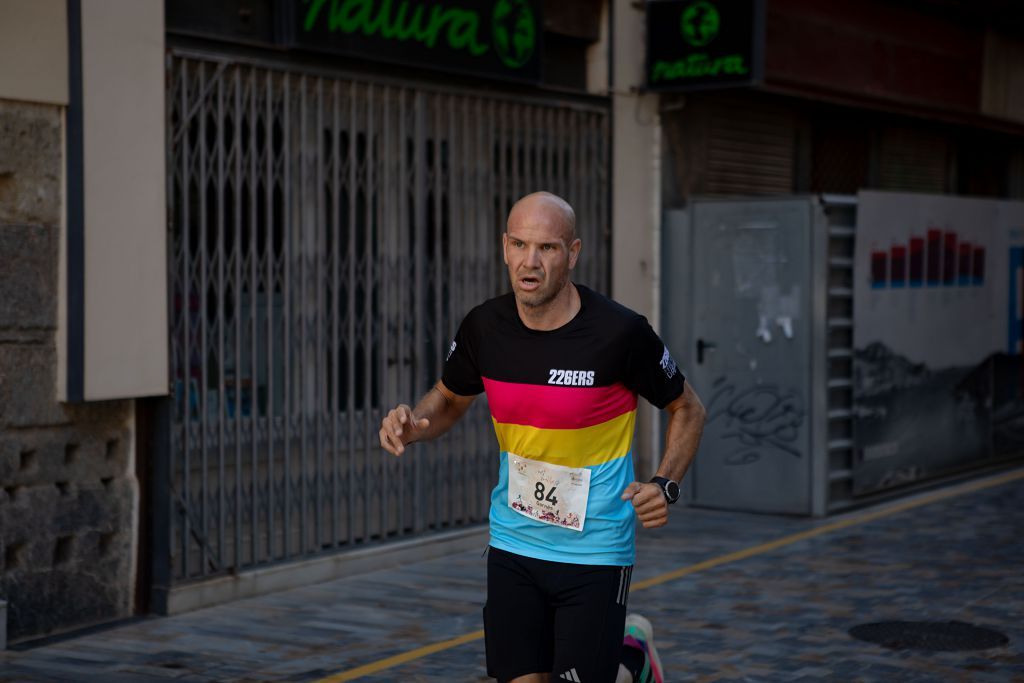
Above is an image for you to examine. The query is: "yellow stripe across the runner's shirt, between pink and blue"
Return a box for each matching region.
[492,411,636,467]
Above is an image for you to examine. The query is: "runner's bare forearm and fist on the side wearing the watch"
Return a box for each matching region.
[623,382,706,528]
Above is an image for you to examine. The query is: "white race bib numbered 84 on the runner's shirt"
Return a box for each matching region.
[509,453,590,531]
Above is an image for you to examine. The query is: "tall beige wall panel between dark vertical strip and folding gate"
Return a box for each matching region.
[82,0,168,400]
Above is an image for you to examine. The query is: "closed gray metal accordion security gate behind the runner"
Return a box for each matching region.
[167,51,609,584]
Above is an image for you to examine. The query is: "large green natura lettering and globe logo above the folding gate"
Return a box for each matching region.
[302,0,538,69]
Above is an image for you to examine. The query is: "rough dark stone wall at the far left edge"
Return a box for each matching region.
[0,100,137,641]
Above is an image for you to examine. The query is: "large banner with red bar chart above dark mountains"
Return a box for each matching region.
[853,191,1024,494]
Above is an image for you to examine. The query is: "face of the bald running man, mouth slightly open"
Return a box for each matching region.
[502,206,581,307]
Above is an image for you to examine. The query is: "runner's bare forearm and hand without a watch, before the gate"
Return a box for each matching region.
[380,380,476,456]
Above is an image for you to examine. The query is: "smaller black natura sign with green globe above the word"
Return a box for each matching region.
[647,0,764,90]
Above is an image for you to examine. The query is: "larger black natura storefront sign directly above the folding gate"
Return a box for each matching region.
[278,0,544,82]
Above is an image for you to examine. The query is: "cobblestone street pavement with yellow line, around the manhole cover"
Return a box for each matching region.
[0,469,1024,683]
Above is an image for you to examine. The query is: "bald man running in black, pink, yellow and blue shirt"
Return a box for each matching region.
[380,193,705,683]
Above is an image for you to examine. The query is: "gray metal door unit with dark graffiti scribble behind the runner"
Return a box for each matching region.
[662,197,855,515]
